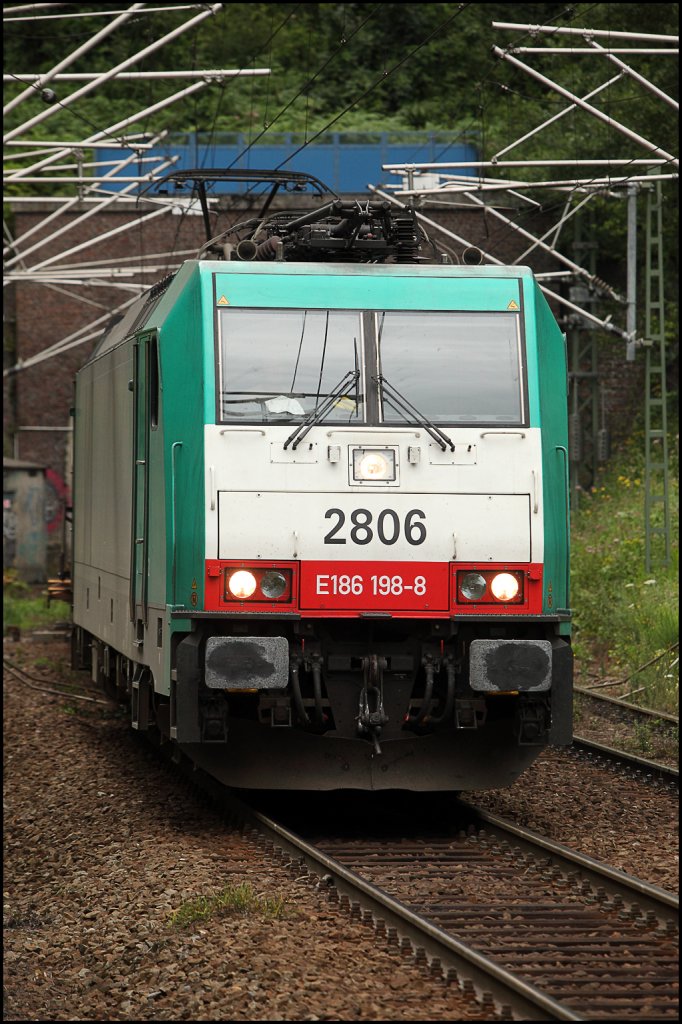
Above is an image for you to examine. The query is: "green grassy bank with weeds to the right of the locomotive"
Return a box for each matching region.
[570,434,679,714]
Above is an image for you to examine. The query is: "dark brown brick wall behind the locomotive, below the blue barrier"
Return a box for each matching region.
[3,198,643,532]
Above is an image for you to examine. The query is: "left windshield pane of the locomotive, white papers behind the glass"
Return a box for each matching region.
[219,309,365,423]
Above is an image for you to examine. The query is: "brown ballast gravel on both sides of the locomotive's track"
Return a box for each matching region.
[3,639,678,1021]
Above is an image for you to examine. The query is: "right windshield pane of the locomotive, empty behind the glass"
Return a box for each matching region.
[377,311,523,424]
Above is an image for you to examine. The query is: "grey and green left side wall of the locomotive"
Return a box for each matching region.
[73,264,206,704]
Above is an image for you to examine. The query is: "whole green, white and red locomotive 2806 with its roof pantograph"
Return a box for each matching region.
[73,170,572,792]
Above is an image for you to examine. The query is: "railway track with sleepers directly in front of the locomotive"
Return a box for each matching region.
[223,790,679,1020]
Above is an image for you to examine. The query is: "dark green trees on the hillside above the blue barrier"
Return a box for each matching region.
[4,3,679,145]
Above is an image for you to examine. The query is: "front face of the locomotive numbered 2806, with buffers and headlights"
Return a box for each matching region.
[174,261,571,791]
